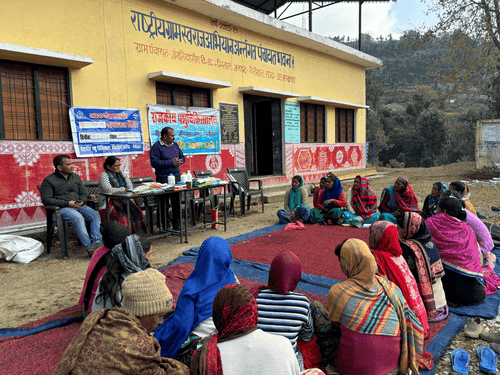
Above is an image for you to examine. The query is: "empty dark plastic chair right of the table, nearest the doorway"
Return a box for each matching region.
[227,168,264,217]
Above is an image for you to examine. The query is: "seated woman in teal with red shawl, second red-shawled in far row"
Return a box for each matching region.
[378,177,419,224]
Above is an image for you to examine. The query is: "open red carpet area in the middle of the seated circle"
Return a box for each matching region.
[231,224,369,281]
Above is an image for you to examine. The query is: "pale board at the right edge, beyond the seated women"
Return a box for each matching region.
[476,120,500,169]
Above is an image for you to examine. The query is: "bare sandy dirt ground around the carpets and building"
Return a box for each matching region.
[0,162,500,369]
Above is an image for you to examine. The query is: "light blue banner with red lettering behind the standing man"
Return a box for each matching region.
[148,104,220,155]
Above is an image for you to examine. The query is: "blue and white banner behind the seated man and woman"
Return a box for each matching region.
[69,107,144,157]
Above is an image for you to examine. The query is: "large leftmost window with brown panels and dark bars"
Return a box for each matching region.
[0,61,71,141]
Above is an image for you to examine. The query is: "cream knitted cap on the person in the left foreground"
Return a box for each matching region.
[122,268,173,318]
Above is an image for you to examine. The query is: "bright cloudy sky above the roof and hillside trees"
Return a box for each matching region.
[280,0,437,39]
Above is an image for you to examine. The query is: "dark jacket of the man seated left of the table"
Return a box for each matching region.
[40,171,87,207]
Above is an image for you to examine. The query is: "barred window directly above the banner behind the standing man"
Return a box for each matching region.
[156,82,211,108]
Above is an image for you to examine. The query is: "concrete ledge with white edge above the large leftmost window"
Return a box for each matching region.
[0,42,94,69]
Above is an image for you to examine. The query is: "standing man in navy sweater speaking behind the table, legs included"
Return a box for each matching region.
[149,126,186,230]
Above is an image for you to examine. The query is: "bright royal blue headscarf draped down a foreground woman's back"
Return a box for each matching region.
[154,237,235,358]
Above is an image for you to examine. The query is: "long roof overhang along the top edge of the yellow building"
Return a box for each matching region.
[165,0,383,69]
